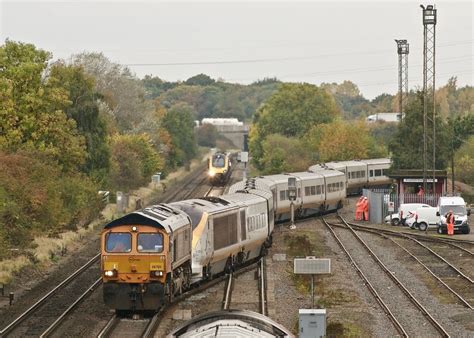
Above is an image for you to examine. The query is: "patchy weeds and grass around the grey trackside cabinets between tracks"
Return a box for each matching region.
[284,228,369,337]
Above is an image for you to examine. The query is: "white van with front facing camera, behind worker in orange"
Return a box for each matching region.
[438,197,471,234]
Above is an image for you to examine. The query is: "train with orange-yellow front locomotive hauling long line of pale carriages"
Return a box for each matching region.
[101,159,390,311]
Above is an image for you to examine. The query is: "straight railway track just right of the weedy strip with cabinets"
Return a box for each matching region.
[323,218,449,337]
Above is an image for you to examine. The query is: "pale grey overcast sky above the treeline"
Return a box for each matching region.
[0,0,474,99]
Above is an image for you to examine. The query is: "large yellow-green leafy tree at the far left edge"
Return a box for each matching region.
[0,40,86,171]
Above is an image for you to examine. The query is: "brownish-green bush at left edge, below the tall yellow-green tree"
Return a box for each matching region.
[0,153,101,257]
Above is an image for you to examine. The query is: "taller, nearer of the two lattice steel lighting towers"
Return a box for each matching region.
[420,5,436,193]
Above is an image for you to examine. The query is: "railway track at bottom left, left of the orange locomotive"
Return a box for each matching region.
[0,254,100,337]
